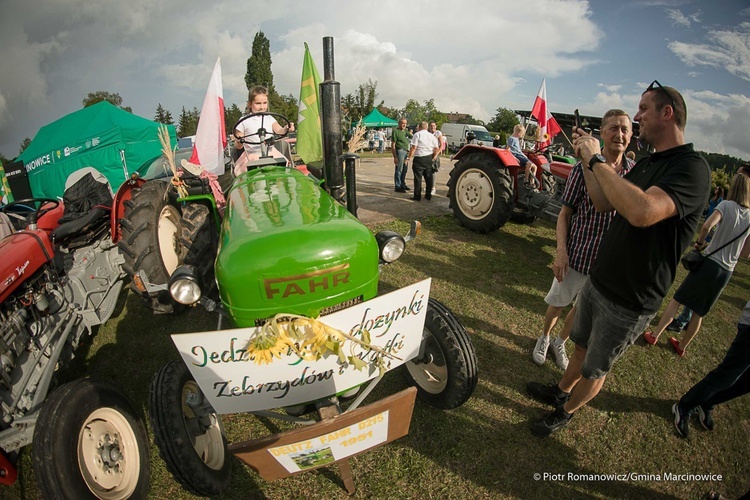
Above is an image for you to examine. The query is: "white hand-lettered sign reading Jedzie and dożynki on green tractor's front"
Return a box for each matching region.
[172,278,431,413]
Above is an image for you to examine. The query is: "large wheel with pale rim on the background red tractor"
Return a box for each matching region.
[448,153,514,233]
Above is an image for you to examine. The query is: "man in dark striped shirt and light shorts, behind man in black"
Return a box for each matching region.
[531,109,634,370]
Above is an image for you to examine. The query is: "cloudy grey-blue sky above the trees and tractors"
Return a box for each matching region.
[0,0,750,159]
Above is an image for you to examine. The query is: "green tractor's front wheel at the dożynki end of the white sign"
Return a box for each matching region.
[404,299,477,410]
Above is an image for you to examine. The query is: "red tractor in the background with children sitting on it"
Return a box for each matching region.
[448,144,573,233]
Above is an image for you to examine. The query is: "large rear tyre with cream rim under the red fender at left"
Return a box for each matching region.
[117,181,184,314]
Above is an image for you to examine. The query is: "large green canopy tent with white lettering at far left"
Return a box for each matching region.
[18,101,177,198]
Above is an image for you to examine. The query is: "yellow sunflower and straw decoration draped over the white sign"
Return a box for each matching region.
[245,314,400,376]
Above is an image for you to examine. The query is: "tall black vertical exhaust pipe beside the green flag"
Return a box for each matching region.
[320,36,346,204]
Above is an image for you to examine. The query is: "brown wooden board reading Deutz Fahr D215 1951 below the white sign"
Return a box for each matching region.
[229,387,417,481]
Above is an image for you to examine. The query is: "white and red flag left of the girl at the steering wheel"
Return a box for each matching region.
[190,58,227,175]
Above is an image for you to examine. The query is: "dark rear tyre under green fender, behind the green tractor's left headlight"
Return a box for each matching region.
[180,203,218,299]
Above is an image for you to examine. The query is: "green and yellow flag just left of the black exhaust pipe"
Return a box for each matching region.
[297,43,323,163]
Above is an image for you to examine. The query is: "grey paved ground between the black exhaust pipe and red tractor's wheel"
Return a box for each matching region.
[356,156,452,224]
